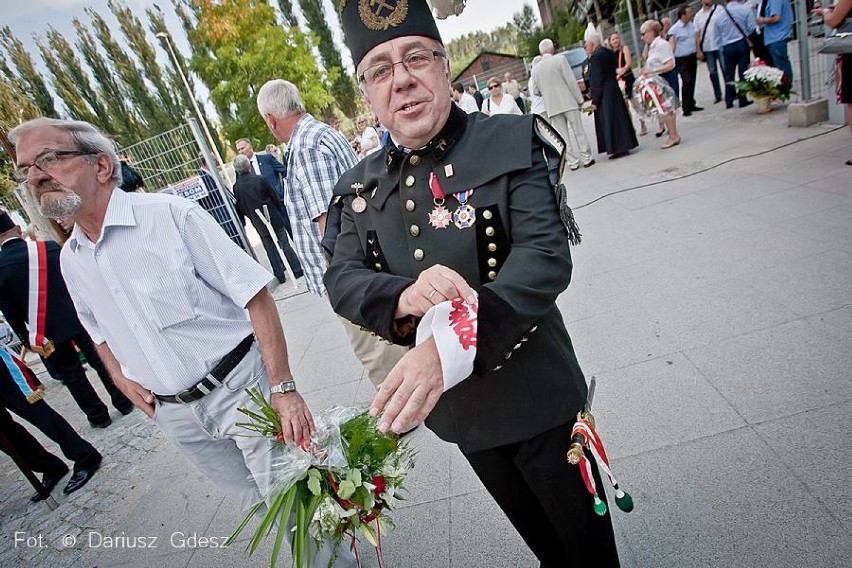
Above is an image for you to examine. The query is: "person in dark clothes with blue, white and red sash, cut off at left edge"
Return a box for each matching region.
[0,347,103,501]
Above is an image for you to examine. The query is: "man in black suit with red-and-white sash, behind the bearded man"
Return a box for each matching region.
[0,211,133,428]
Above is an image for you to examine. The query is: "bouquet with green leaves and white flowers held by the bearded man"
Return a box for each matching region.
[228,390,414,568]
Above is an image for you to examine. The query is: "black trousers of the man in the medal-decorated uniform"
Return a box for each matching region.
[465,420,620,568]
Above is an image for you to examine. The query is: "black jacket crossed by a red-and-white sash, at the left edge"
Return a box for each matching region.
[0,239,84,346]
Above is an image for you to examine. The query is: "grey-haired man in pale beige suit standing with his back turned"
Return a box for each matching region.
[532,38,595,170]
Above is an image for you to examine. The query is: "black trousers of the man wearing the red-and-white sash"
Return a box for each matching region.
[41,333,133,424]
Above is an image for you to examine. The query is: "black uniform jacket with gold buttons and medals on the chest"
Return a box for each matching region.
[325,107,587,452]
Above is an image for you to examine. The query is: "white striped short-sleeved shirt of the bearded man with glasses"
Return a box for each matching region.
[60,189,272,394]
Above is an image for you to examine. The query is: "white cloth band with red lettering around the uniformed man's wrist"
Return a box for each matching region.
[416,298,479,392]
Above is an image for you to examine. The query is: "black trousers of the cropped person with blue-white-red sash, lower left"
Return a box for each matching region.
[0,400,102,476]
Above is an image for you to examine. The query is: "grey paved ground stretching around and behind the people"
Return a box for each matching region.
[0,77,852,568]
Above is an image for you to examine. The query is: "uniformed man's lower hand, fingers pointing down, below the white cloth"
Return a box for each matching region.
[370,338,444,434]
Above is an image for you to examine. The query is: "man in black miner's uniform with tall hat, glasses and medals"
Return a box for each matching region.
[325,0,619,568]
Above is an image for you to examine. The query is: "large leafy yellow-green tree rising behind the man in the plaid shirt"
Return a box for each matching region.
[189,0,332,144]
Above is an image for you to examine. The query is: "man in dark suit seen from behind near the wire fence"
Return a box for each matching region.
[234,155,302,284]
